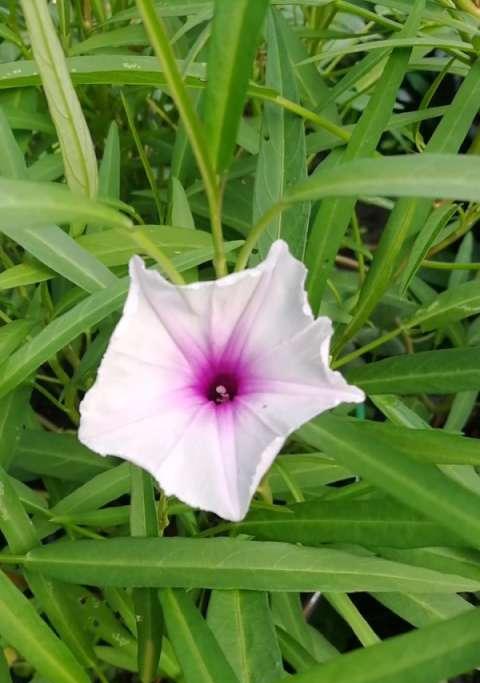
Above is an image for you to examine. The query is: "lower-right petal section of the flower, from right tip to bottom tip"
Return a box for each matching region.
[214,318,365,521]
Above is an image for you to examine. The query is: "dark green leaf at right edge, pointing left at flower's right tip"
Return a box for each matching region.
[345,348,480,394]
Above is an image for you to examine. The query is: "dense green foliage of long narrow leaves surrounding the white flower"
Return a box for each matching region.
[0,0,480,683]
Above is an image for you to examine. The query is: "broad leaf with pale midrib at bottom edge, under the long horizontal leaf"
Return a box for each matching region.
[207,591,283,683]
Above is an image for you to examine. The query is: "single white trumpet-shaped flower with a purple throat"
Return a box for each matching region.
[79,241,364,521]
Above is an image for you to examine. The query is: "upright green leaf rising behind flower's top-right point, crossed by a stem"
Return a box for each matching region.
[253,9,310,260]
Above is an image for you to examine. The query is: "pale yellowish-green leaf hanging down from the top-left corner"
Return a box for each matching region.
[21,0,98,197]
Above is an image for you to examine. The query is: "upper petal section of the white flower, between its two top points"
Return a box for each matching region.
[119,240,313,362]
